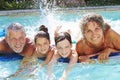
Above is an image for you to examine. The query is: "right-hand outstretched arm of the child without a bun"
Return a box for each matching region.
[59,51,78,80]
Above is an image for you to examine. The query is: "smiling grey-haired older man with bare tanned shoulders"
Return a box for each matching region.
[0,23,35,56]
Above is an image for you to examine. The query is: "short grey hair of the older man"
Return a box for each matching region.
[6,23,25,36]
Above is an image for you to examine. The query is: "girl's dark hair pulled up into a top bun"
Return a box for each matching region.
[34,25,50,43]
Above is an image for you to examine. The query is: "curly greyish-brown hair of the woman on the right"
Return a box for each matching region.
[80,13,108,34]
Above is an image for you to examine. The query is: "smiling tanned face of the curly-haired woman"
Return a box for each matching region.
[84,22,104,45]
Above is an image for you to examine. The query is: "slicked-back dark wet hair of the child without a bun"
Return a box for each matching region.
[54,32,72,45]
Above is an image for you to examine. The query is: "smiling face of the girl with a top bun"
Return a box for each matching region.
[35,38,50,54]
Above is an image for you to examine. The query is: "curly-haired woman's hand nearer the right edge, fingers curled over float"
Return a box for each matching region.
[98,48,111,63]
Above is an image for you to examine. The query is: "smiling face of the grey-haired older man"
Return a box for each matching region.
[6,31,26,53]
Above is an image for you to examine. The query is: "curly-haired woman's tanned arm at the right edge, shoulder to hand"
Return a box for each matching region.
[98,29,120,63]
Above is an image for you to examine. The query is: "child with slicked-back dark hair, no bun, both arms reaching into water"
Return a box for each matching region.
[48,26,78,80]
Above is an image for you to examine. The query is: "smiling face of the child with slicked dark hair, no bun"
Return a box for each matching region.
[56,39,72,58]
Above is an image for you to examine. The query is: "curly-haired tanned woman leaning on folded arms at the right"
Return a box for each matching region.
[76,13,120,63]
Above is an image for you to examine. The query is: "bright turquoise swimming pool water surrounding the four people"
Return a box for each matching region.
[0,11,120,80]
